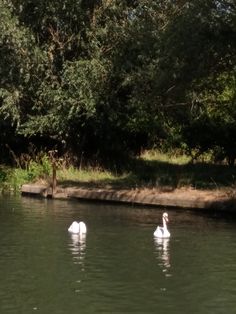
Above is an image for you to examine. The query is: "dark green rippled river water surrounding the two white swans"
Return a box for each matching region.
[0,197,236,314]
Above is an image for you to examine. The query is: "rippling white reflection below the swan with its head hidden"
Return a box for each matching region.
[69,233,86,270]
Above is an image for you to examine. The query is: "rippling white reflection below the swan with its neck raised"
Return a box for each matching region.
[154,237,171,272]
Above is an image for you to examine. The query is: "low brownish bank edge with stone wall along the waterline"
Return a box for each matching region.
[21,184,236,212]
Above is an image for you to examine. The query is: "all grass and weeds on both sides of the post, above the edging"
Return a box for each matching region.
[0,151,236,192]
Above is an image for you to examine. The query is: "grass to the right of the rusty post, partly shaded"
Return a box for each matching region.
[58,151,236,189]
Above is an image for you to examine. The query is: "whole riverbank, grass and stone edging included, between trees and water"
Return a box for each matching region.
[0,151,236,213]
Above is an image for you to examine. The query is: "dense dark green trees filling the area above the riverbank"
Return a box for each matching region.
[0,0,236,165]
